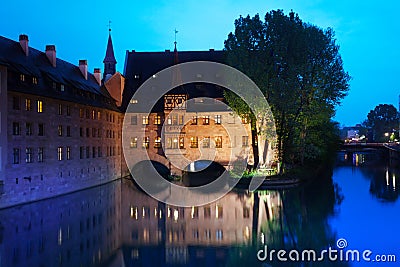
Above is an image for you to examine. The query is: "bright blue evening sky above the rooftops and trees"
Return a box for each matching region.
[0,0,400,126]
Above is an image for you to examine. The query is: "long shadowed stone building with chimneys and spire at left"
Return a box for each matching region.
[0,35,123,208]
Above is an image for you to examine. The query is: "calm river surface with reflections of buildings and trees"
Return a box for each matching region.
[0,153,400,267]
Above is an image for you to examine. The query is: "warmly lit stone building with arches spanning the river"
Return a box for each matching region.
[122,43,253,178]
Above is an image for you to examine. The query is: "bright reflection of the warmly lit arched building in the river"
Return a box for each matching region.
[121,180,281,266]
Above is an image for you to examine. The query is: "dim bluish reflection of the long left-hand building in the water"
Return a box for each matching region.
[0,182,121,267]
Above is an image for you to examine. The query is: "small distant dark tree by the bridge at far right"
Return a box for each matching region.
[364,104,399,142]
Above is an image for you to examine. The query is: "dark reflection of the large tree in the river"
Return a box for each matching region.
[261,172,347,266]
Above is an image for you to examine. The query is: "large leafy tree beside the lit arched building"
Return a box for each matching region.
[225,10,350,170]
